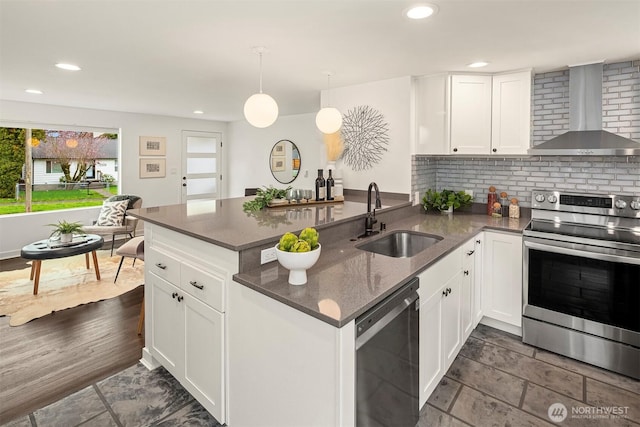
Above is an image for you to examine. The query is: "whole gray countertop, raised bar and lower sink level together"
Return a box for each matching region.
[128,196,529,327]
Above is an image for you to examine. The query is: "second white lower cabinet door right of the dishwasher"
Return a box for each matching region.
[441,272,462,372]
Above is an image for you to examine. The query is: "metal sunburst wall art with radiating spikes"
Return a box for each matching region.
[341,105,389,171]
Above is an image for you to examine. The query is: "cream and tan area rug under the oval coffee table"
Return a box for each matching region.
[0,251,144,326]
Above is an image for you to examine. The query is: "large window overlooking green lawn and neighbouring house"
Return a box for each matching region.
[0,123,120,215]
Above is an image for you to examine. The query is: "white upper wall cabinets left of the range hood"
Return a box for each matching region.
[415,70,531,155]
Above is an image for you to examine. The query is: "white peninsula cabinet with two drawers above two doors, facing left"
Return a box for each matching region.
[145,225,237,424]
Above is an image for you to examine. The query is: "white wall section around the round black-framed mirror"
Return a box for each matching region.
[225,113,327,197]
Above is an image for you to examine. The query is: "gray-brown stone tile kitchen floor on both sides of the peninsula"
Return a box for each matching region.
[6,325,640,427]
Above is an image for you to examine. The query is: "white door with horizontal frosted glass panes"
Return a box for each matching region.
[182,131,222,203]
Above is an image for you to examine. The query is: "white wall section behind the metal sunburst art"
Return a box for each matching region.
[322,76,411,194]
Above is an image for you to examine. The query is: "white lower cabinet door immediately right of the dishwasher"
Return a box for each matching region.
[419,288,445,407]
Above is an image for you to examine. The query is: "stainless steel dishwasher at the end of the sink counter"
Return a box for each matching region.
[356,278,420,427]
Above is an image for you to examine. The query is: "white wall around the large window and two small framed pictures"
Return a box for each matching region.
[0,100,227,259]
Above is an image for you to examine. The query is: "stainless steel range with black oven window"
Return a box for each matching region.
[522,190,640,379]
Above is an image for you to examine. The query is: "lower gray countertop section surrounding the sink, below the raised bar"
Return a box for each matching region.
[234,210,529,327]
